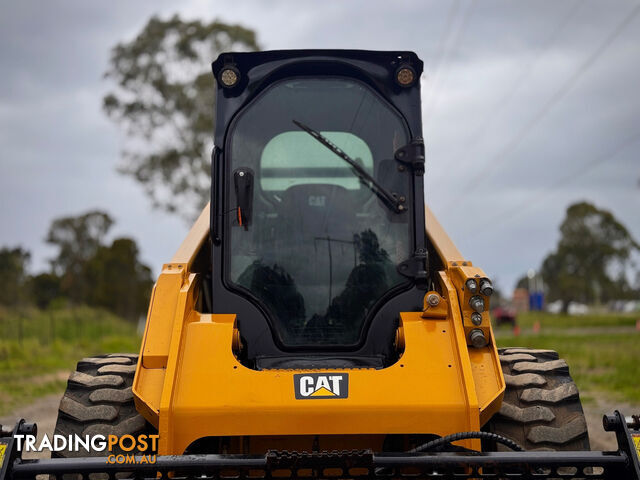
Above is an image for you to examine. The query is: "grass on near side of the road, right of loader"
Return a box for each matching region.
[498,332,640,405]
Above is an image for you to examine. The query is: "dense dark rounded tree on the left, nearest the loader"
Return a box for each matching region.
[83,238,153,320]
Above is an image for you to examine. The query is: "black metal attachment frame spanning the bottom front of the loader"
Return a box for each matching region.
[0,411,640,480]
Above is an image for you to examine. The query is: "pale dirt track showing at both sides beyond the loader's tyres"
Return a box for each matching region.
[0,392,640,458]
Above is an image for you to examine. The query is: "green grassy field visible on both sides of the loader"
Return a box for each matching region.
[0,308,640,415]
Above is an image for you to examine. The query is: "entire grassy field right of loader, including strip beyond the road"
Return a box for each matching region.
[496,312,640,405]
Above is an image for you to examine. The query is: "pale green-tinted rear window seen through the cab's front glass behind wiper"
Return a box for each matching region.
[260,131,373,192]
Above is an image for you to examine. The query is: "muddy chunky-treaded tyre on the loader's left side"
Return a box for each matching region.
[55,353,155,457]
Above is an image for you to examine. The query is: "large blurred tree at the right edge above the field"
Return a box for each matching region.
[542,202,640,311]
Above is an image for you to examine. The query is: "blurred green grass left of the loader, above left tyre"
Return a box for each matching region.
[0,307,140,415]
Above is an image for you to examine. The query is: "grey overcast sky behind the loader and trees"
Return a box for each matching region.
[0,0,640,289]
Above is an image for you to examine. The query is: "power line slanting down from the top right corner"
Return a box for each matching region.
[462,4,640,195]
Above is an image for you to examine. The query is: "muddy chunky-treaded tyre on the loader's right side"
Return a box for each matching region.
[483,348,589,450]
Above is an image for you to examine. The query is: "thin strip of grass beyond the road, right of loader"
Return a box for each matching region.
[508,312,640,330]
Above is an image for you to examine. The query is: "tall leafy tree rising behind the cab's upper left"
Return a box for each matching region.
[103,15,258,216]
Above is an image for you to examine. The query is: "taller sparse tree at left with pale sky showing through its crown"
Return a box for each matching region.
[46,210,113,303]
